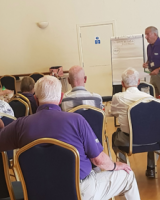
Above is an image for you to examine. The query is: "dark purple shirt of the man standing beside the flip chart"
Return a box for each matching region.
[147,38,160,71]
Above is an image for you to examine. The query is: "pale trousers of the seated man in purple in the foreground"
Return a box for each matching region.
[80,170,140,200]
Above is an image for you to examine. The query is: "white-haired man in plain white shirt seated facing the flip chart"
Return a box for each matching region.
[111,68,154,177]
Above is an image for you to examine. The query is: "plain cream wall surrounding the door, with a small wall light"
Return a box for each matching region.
[0,0,160,82]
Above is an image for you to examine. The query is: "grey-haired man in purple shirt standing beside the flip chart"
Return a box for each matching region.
[143,26,160,97]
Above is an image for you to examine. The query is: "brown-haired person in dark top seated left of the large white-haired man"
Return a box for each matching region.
[20,76,38,114]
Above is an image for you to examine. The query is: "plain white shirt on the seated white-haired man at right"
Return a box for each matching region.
[111,87,152,133]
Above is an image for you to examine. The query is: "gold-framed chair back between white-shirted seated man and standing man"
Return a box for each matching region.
[138,81,156,97]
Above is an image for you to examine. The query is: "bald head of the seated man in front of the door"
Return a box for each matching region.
[68,66,86,88]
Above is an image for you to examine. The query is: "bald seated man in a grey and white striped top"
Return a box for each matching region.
[61,66,102,111]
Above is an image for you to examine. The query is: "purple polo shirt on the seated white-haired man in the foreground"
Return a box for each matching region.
[0,104,103,179]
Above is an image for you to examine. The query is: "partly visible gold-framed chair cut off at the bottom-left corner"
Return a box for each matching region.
[0,152,24,200]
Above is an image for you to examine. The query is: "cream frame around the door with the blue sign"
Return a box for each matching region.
[77,20,116,67]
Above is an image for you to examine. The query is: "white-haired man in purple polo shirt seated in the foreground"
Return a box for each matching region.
[0,76,140,200]
